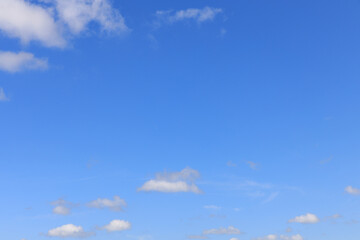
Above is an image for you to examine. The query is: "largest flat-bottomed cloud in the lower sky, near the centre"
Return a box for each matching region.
[138,168,201,193]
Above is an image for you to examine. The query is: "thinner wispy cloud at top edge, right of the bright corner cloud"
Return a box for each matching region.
[55,0,129,34]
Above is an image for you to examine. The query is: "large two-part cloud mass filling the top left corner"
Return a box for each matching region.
[0,0,128,47]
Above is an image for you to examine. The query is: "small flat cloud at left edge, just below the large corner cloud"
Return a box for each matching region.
[0,51,48,73]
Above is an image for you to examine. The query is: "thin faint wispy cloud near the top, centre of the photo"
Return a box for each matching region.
[156,7,223,24]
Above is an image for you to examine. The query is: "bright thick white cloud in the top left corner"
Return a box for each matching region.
[0,0,66,47]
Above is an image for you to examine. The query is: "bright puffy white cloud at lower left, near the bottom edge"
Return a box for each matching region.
[47,224,94,238]
